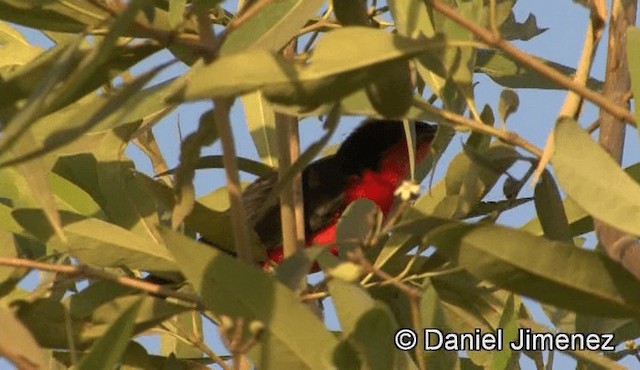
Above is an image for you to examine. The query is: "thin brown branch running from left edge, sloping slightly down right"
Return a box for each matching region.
[0,257,204,310]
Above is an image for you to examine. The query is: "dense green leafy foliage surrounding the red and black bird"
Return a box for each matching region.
[0,0,640,369]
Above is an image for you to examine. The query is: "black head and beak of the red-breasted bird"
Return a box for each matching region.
[336,119,436,175]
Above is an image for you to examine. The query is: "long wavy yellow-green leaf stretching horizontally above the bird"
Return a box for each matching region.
[176,27,441,107]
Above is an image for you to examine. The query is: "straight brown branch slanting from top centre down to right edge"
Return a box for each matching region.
[424,0,635,123]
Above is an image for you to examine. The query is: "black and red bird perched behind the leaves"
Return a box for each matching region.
[242,118,437,267]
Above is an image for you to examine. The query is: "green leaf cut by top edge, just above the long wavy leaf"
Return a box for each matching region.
[220,0,324,55]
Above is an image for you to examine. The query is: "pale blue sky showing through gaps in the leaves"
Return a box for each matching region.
[6,0,640,369]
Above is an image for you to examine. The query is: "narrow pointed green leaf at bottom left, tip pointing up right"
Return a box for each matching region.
[78,299,142,370]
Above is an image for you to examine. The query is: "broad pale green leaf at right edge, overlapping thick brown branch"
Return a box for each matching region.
[551,119,640,235]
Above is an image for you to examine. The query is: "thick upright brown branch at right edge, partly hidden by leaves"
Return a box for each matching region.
[594,0,640,278]
